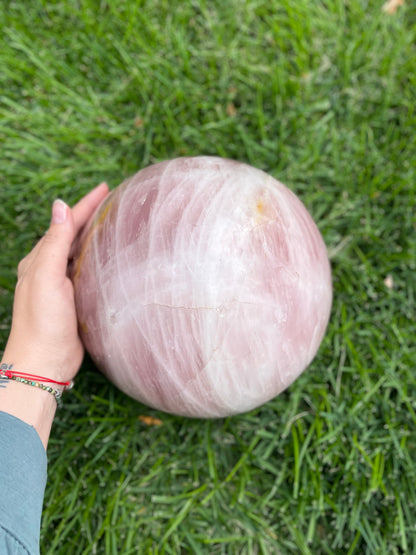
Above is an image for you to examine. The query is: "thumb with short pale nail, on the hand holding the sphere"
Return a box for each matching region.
[38,199,75,279]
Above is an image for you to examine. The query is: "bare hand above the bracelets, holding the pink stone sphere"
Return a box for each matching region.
[2,183,109,382]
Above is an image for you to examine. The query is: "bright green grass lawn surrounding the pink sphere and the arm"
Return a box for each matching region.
[0,0,416,555]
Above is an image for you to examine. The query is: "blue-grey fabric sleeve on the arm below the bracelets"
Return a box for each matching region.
[0,411,47,555]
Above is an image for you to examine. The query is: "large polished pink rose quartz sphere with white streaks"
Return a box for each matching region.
[71,156,332,417]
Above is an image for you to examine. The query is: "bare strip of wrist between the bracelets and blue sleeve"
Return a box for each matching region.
[0,360,57,449]
